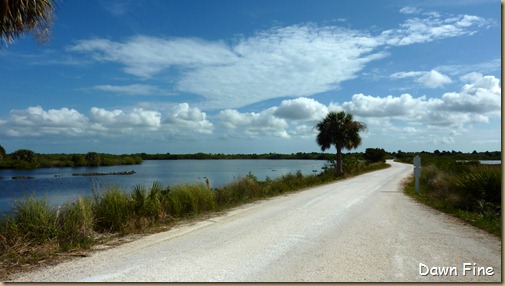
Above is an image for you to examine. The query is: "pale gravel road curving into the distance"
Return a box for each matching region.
[7,162,501,282]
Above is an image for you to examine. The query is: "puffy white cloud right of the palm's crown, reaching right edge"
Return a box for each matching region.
[341,73,501,128]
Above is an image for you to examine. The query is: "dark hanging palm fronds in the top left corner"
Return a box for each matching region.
[0,0,55,44]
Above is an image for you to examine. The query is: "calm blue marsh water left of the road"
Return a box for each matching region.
[0,160,327,212]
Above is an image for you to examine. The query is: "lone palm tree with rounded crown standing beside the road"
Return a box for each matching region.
[315,111,366,175]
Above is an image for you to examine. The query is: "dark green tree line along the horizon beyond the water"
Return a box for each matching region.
[0,145,501,169]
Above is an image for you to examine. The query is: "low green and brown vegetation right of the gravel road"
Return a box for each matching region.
[405,156,501,237]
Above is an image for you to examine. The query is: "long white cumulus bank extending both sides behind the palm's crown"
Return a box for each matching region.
[216,73,501,139]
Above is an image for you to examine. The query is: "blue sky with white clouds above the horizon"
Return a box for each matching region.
[0,0,501,154]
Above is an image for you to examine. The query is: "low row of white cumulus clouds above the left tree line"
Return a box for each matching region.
[0,103,213,137]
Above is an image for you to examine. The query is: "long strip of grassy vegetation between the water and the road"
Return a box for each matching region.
[0,159,389,278]
